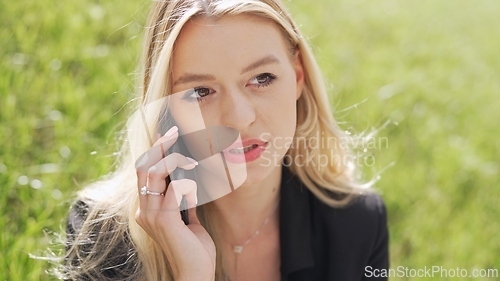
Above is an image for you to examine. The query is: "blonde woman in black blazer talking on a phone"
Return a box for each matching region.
[60,0,388,280]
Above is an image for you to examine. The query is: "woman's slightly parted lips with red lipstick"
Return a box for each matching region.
[224,139,268,164]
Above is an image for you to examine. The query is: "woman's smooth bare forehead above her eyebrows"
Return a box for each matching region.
[172,15,289,75]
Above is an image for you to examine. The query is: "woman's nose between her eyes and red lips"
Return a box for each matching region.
[221,89,256,131]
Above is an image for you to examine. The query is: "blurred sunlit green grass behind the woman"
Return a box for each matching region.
[0,0,500,280]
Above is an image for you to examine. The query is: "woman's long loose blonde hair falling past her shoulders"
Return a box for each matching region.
[60,0,372,281]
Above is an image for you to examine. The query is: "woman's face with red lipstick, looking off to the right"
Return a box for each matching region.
[171,16,304,187]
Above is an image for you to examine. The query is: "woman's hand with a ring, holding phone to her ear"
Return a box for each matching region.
[136,126,215,280]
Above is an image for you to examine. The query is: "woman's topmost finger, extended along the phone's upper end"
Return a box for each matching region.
[135,126,179,173]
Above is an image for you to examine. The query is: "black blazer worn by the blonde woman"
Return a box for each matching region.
[67,168,389,281]
